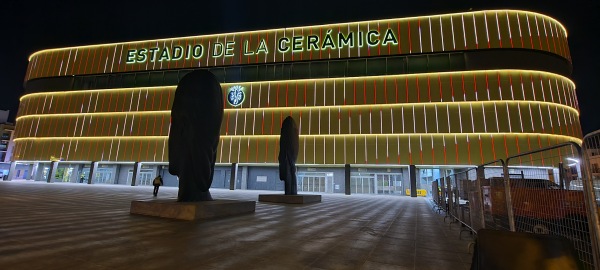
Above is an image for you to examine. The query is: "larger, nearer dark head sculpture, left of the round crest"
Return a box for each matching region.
[169,70,223,202]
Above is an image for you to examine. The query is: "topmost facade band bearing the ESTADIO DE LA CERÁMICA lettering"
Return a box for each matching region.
[26,10,570,80]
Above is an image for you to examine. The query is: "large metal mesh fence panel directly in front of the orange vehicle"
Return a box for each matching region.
[503,143,597,269]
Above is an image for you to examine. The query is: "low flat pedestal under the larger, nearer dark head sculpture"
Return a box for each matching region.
[129,199,256,220]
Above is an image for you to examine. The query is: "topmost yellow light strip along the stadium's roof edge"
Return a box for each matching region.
[29,9,568,61]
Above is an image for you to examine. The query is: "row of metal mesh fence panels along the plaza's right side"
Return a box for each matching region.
[434,142,600,269]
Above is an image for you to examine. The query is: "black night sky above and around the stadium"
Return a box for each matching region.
[0,0,600,134]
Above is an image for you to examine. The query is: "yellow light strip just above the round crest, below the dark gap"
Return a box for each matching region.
[19,69,575,101]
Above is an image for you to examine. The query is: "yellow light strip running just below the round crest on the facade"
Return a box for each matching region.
[16,100,579,122]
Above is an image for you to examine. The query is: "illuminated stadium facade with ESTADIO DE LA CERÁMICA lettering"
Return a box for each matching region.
[13,10,582,194]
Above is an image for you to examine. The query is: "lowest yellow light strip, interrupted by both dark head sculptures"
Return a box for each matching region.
[14,132,582,145]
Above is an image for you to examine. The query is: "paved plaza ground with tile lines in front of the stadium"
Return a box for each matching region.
[0,181,472,270]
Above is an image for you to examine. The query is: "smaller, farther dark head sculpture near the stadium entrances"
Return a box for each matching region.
[279,116,299,195]
